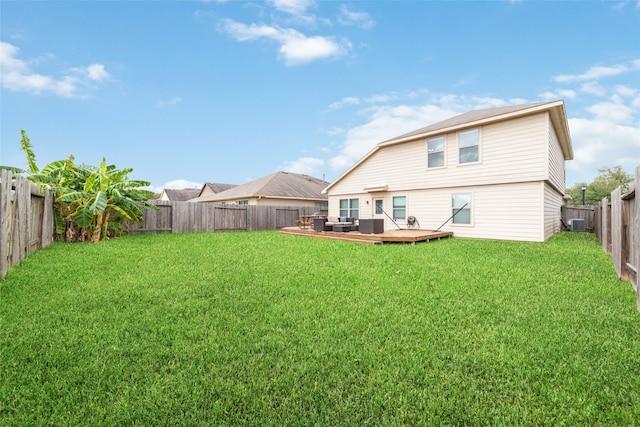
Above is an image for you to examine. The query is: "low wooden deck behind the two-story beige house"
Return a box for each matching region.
[280,227,453,245]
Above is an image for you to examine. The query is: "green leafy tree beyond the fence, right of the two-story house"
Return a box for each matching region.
[567,166,634,205]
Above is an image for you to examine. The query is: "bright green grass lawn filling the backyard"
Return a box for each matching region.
[0,232,640,426]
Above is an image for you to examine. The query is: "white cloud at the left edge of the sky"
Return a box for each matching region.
[0,41,111,98]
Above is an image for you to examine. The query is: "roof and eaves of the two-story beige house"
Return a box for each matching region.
[325,101,573,192]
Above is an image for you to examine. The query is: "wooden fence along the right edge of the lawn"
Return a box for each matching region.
[595,166,640,310]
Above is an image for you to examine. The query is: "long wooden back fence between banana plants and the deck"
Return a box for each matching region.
[129,200,319,233]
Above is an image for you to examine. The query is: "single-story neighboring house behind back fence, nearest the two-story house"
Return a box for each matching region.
[192,172,329,211]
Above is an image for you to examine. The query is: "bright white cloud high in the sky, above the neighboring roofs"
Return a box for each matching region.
[222,19,351,65]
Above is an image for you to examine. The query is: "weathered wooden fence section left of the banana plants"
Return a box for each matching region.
[0,170,55,279]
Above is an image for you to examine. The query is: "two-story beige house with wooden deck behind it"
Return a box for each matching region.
[325,101,573,242]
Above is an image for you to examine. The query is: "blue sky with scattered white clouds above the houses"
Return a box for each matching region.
[0,0,640,190]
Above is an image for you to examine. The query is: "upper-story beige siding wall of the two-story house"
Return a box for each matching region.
[330,113,548,195]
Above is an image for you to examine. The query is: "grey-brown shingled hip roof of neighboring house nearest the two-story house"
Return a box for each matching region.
[193,172,329,202]
